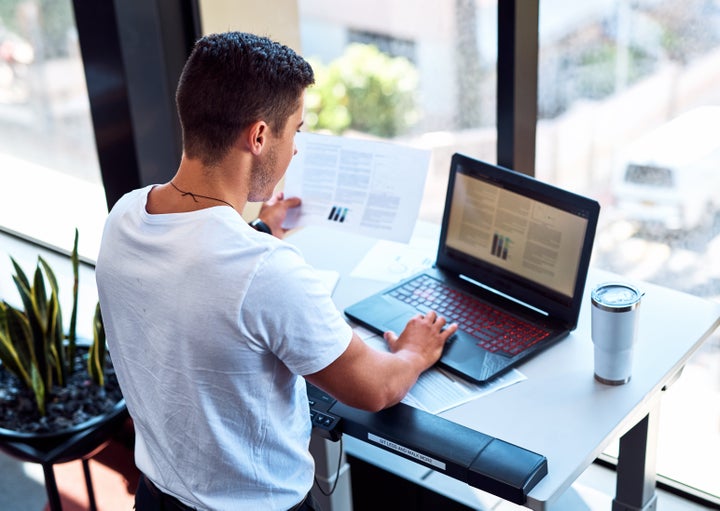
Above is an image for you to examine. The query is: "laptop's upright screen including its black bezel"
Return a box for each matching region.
[438,155,599,326]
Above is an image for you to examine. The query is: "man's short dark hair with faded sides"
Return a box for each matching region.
[175,32,315,165]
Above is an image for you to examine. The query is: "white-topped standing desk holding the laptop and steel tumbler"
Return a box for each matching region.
[287,223,720,511]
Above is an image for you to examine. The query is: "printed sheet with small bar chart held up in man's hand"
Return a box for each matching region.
[284,132,430,242]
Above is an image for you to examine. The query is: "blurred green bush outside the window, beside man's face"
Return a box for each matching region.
[305,44,419,137]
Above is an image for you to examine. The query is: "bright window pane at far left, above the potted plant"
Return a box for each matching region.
[0,0,107,260]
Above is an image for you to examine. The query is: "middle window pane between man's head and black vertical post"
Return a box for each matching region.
[299,0,497,222]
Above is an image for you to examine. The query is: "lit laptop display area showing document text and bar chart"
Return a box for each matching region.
[446,173,588,296]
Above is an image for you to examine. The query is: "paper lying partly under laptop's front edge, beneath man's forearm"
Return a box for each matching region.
[354,326,527,414]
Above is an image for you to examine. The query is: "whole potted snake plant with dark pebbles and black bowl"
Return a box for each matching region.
[0,229,126,454]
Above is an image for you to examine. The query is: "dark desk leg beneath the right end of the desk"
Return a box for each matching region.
[612,403,660,511]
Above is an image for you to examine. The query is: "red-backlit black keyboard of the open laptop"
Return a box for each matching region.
[388,275,549,356]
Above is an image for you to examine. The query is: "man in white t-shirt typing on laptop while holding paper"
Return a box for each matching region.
[96,32,456,511]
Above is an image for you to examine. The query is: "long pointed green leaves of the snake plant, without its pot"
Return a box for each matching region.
[0,230,105,415]
